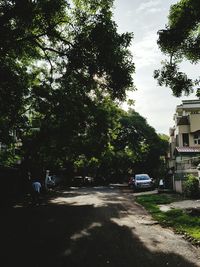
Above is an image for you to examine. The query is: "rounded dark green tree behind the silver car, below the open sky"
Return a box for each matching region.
[109,109,168,182]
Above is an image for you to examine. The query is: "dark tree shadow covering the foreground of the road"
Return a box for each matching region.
[1,190,196,267]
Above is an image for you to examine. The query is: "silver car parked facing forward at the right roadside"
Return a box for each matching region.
[131,173,154,190]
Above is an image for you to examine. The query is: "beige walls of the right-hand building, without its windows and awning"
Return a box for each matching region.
[168,99,200,193]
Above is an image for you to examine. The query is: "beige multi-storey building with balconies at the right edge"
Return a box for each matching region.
[169,100,200,192]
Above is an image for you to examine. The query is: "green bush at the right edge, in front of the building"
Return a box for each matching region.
[183,174,200,198]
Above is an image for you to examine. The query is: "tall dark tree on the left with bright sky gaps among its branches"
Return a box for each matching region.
[0,0,134,168]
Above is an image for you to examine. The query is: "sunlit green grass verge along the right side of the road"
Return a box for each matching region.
[136,194,200,243]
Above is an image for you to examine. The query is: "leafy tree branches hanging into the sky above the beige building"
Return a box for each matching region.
[154,0,200,97]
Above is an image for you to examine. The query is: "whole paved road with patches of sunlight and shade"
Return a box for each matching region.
[0,185,200,267]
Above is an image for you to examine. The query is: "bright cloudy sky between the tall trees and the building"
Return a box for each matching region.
[113,0,199,135]
